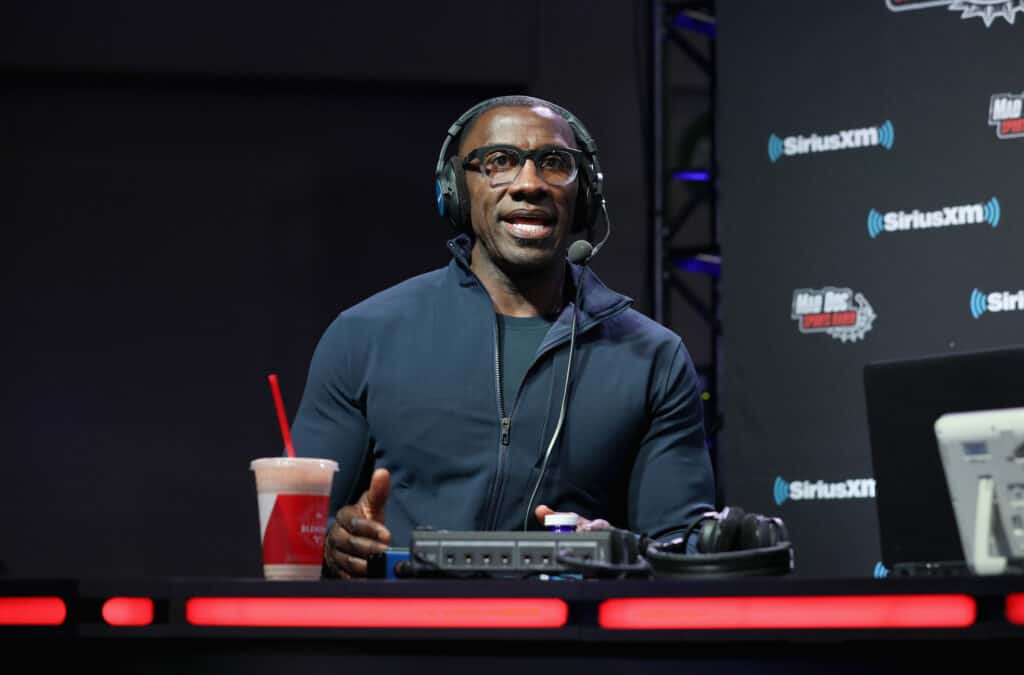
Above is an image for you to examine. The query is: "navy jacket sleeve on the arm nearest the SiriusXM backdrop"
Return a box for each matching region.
[629,340,715,550]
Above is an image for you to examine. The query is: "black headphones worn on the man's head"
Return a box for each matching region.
[434,96,604,234]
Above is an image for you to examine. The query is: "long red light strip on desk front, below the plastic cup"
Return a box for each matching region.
[185,597,568,628]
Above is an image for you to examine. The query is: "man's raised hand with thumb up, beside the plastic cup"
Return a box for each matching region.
[324,469,391,579]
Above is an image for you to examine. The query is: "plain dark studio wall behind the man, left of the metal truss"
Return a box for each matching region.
[0,0,675,577]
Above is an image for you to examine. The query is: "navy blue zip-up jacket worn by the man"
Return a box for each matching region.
[293,237,714,546]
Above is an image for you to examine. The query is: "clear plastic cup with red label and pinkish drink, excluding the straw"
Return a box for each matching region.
[249,457,338,580]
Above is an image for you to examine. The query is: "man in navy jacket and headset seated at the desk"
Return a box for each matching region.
[293,96,714,578]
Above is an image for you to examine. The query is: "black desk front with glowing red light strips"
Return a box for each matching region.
[0,577,1024,675]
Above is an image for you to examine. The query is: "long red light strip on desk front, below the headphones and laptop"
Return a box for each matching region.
[598,595,977,630]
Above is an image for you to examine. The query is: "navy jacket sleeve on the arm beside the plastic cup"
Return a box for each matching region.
[292,314,373,514]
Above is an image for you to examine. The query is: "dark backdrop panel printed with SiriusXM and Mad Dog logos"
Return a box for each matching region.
[717,0,1024,576]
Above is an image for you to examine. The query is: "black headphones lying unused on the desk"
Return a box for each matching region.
[645,506,793,577]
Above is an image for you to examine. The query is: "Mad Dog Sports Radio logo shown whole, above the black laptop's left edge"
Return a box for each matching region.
[791,286,876,342]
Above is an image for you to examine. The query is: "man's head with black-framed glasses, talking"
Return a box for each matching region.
[458,101,583,273]
